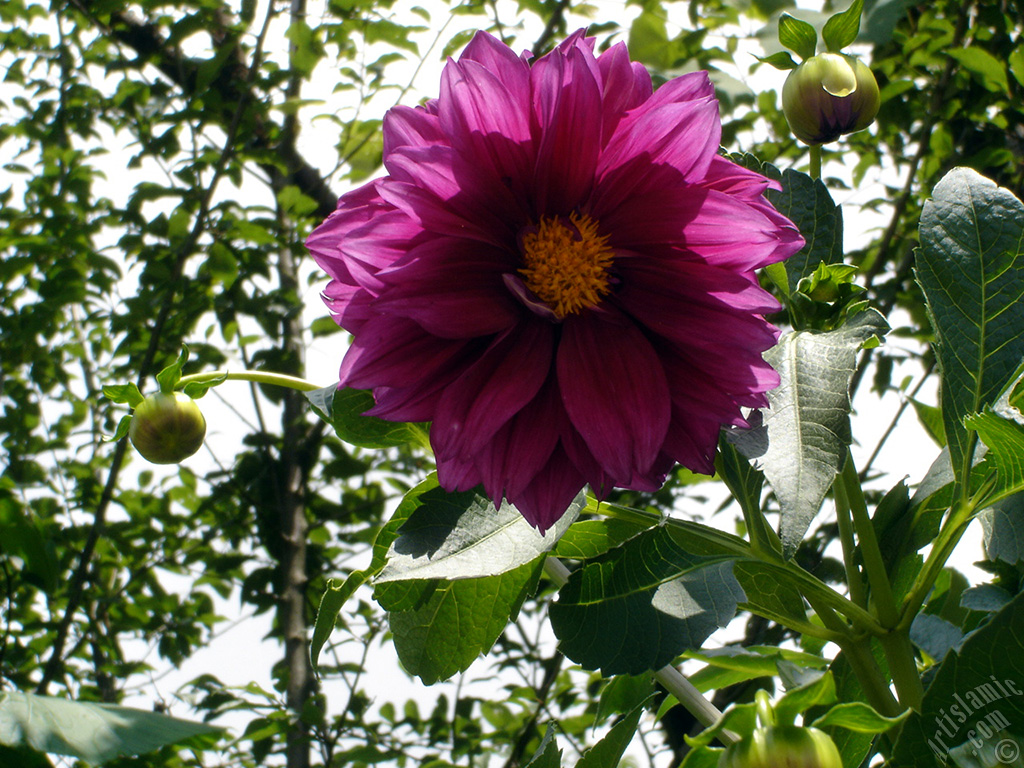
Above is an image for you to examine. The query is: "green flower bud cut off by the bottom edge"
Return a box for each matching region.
[718,725,843,768]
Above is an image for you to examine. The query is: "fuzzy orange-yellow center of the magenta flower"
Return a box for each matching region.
[519,213,613,319]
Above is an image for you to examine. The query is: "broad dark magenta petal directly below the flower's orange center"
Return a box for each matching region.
[558,312,670,482]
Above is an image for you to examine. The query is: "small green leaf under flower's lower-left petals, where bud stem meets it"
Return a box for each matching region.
[305,386,429,449]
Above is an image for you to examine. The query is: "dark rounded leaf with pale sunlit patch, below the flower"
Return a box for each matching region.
[550,526,744,676]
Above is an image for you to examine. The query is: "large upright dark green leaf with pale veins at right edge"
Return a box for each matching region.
[916,168,1024,481]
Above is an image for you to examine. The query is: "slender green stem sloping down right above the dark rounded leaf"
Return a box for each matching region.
[587,501,886,640]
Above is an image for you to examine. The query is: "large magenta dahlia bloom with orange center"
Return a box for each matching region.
[306,32,803,531]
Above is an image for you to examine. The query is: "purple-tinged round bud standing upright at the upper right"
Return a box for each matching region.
[782,53,880,144]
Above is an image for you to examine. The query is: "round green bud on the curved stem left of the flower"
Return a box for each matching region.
[128,392,206,464]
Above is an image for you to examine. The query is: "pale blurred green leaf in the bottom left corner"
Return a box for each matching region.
[0,691,220,763]
